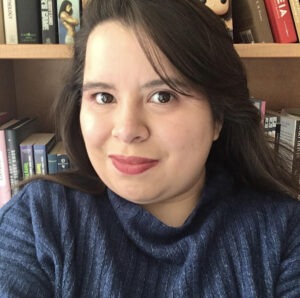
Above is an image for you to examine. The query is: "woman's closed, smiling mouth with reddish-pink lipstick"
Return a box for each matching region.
[108,155,159,175]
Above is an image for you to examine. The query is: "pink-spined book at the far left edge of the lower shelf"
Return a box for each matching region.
[0,119,19,207]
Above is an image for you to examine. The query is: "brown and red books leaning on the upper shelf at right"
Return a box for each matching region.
[232,0,300,43]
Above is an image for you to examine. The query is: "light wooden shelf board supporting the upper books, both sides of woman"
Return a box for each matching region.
[0,43,300,59]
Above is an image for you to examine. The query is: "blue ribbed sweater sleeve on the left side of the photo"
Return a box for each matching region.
[0,187,53,298]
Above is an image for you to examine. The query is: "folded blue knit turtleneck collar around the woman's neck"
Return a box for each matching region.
[107,165,232,263]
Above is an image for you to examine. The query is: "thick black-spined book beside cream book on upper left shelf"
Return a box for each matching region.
[16,0,42,43]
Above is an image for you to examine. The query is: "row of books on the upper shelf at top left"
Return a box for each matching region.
[0,0,85,44]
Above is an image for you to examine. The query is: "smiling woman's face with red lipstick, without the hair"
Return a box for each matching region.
[80,21,220,204]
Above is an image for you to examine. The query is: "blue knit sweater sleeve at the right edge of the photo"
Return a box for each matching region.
[275,204,300,298]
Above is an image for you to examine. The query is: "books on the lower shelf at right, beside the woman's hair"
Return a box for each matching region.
[250,97,300,194]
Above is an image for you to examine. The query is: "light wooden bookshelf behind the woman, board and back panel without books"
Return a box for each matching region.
[0,44,300,132]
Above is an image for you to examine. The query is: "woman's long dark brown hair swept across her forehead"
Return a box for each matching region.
[27,0,297,195]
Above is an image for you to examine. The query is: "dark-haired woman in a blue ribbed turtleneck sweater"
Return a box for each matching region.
[0,0,300,297]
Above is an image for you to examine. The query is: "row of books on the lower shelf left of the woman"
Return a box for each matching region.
[0,112,70,207]
